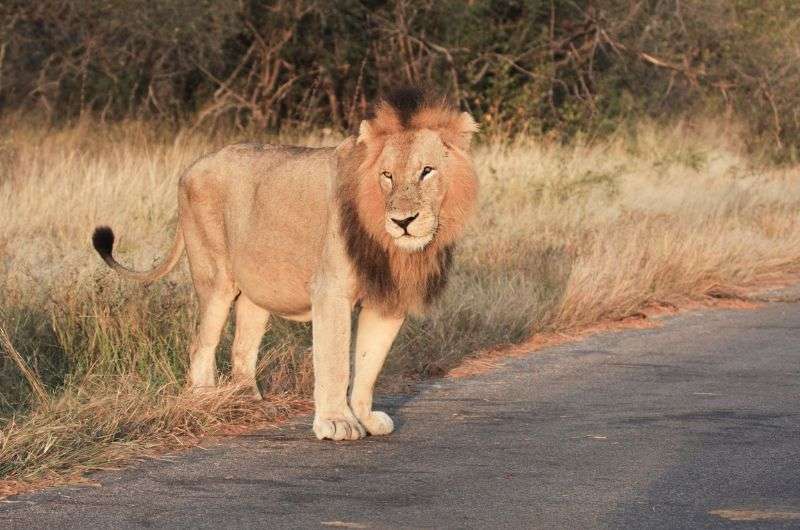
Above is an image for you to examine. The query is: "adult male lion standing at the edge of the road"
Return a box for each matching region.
[92,89,477,440]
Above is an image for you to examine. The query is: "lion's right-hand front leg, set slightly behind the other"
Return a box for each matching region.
[350,306,405,435]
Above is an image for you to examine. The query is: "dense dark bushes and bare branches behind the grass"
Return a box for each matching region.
[0,0,800,159]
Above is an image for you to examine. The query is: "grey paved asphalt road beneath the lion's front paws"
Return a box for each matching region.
[0,296,800,528]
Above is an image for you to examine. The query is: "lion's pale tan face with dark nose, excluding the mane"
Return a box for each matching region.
[374,130,448,252]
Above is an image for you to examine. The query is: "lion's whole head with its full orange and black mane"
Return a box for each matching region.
[339,89,477,309]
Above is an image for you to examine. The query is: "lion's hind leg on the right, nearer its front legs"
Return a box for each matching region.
[231,293,269,400]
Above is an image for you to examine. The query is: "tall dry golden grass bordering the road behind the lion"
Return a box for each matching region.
[0,117,800,488]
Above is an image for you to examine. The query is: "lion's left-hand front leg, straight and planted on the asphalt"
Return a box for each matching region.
[311,290,366,440]
